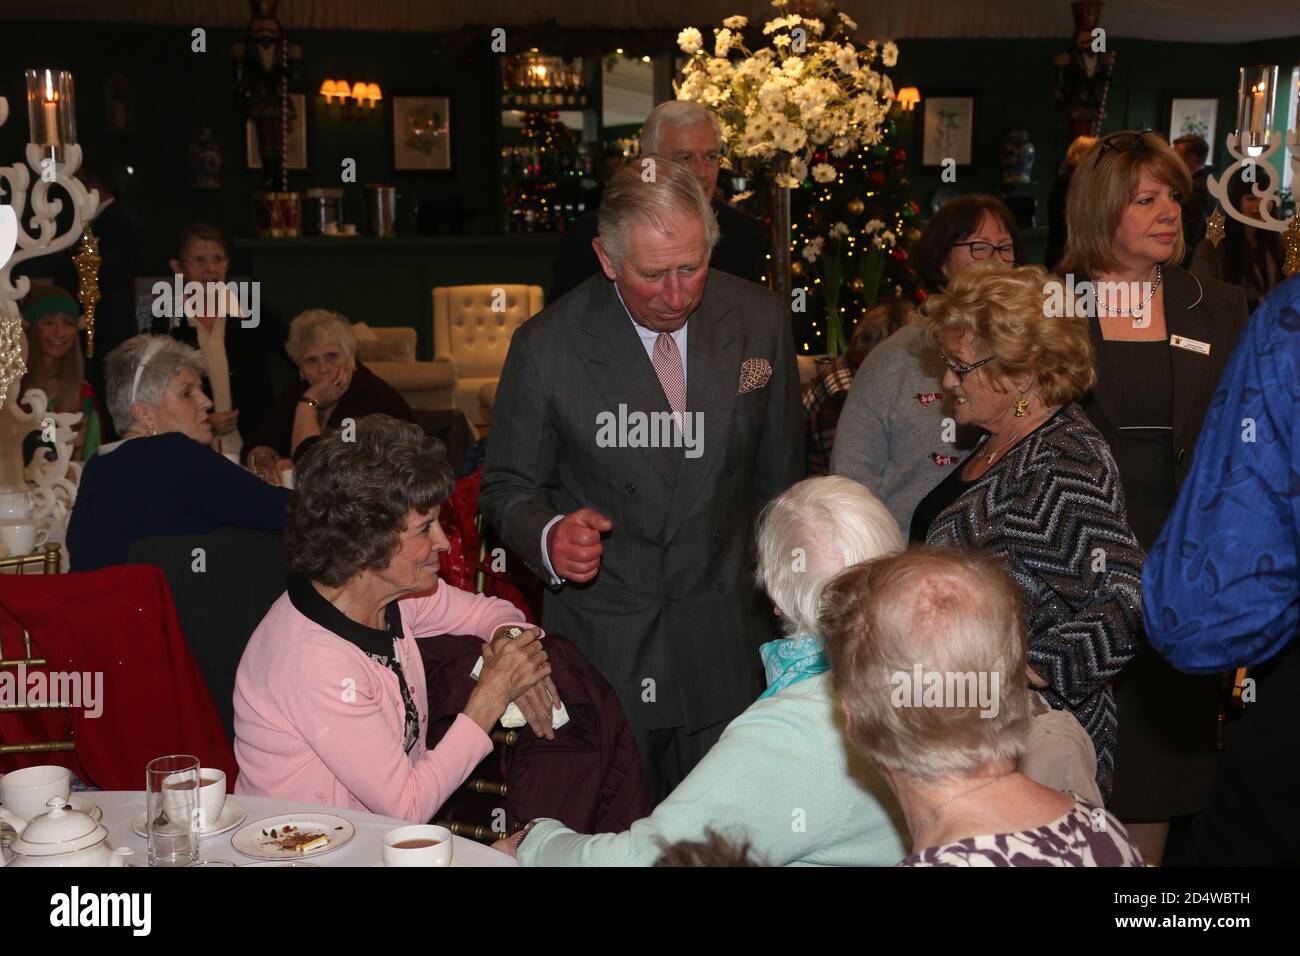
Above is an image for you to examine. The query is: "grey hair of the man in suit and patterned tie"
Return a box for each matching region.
[595,156,718,269]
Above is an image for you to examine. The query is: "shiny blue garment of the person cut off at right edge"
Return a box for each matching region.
[1143,276,1300,674]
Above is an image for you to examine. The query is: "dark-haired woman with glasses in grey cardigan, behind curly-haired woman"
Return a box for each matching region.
[831,195,1024,532]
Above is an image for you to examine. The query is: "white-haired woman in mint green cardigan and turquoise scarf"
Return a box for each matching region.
[497,477,905,866]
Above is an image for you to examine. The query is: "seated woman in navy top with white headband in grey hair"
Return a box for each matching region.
[68,336,287,571]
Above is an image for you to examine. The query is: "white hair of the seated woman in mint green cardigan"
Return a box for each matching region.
[757,475,905,635]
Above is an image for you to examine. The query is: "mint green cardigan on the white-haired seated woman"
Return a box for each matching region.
[519,674,907,866]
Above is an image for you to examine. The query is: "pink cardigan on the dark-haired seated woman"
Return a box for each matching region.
[234,580,528,823]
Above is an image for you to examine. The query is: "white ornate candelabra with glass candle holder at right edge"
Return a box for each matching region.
[1205,66,1300,276]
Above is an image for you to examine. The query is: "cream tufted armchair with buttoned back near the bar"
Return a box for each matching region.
[433,284,543,427]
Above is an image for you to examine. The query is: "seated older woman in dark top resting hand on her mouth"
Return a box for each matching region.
[244,308,415,485]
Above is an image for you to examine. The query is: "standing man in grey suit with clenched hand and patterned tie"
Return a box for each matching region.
[480,157,803,801]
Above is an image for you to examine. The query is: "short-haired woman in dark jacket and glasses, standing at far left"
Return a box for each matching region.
[152,222,285,455]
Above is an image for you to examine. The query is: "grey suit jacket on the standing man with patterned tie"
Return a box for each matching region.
[478,269,803,732]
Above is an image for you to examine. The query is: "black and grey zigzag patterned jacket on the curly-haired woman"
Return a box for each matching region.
[926,405,1145,799]
